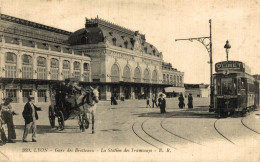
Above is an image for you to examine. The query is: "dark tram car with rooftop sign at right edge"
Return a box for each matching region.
[213,61,260,117]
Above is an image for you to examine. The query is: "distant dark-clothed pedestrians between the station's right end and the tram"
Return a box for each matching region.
[146,93,193,113]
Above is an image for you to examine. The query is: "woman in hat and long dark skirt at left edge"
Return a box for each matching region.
[1,98,17,143]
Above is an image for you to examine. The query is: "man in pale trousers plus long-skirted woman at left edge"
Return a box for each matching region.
[0,96,41,145]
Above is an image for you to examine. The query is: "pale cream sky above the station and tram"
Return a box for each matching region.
[0,0,260,84]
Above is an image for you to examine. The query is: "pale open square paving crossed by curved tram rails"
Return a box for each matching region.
[0,98,260,161]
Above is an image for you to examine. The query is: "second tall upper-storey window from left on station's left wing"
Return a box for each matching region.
[22,55,33,79]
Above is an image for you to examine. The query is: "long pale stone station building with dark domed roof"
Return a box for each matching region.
[0,14,184,103]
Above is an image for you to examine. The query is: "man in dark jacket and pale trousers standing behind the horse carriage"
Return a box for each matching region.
[23,96,41,142]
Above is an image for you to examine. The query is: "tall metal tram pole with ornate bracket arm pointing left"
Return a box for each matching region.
[175,19,214,112]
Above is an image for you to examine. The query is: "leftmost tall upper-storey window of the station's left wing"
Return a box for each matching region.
[5,52,17,78]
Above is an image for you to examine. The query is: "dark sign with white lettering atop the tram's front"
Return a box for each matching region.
[215,61,245,72]
